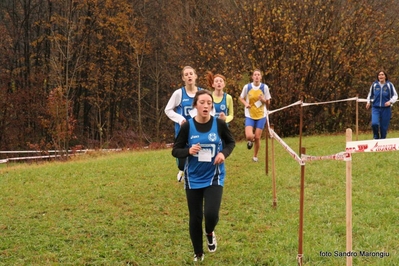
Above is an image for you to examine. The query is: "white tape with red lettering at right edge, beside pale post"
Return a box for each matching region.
[346,138,399,153]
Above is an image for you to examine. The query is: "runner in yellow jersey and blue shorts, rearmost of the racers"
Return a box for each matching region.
[239,69,271,162]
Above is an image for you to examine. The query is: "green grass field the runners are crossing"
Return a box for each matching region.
[0,132,399,266]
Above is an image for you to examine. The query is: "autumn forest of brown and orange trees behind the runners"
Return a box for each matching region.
[0,0,399,150]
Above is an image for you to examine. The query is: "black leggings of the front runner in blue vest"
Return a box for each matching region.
[186,186,223,254]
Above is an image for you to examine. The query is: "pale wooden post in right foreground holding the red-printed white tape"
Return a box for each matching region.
[346,128,352,266]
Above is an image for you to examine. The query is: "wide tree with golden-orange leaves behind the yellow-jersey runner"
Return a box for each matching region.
[181,0,397,135]
